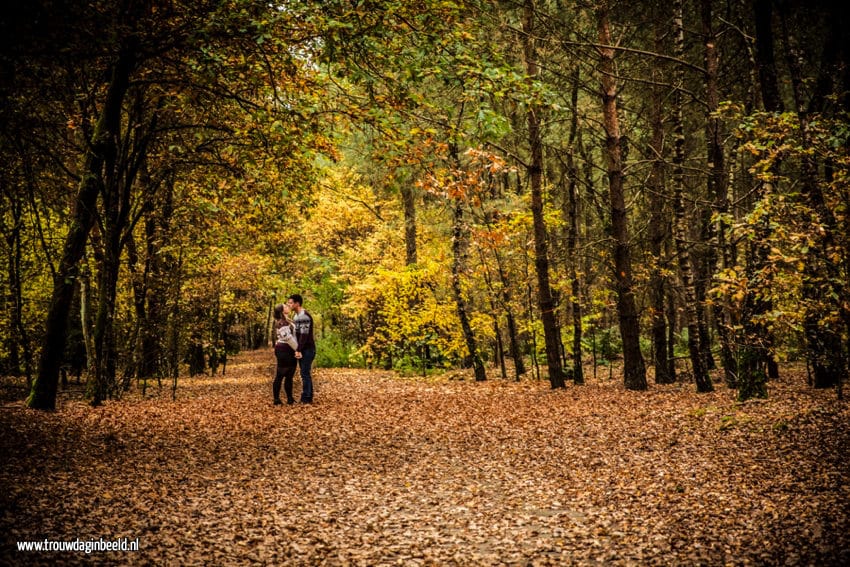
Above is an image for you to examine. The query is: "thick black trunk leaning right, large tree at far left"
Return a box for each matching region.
[27,42,136,409]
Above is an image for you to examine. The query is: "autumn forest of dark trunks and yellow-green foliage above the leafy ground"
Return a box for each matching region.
[0,0,850,561]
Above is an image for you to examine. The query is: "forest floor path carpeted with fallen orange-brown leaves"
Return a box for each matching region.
[0,351,850,565]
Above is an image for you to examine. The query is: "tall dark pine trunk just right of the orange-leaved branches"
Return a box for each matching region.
[523,0,565,388]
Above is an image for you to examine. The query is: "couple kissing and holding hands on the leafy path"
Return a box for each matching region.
[272,293,316,406]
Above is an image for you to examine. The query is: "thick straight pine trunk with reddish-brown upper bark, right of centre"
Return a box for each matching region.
[596,2,647,390]
